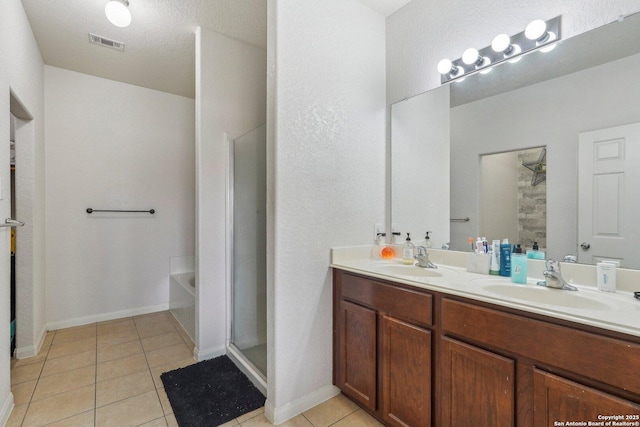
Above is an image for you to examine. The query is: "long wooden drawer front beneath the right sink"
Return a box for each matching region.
[442,298,640,395]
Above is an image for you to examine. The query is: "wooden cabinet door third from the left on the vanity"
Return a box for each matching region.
[440,338,515,427]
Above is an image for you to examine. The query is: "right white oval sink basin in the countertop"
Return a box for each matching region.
[480,279,611,310]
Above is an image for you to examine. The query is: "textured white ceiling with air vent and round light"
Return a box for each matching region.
[22,0,410,98]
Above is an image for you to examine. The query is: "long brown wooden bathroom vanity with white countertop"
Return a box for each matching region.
[332,249,640,427]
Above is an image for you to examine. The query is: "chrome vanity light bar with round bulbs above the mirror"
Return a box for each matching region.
[438,16,560,84]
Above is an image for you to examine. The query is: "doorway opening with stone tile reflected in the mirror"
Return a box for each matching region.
[479,148,547,250]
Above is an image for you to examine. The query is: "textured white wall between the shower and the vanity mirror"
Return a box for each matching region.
[267,0,385,422]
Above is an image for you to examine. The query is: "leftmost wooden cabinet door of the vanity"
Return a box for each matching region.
[336,301,377,411]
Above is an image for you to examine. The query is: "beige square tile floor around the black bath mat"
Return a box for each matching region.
[7,312,382,427]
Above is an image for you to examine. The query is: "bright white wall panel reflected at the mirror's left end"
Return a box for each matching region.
[391,86,450,248]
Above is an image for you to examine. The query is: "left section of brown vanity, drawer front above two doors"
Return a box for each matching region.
[334,270,432,427]
